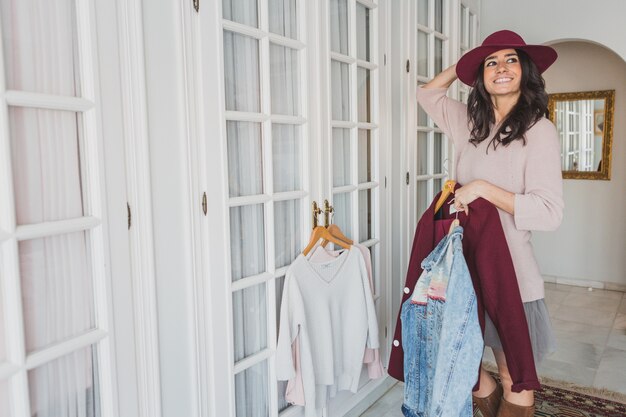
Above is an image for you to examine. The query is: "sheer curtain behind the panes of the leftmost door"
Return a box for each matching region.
[0,0,98,417]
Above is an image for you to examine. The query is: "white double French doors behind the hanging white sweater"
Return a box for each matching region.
[197,0,388,417]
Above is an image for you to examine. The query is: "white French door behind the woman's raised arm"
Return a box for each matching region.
[402,0,479,271]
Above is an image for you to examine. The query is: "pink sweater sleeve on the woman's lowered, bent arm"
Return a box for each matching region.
[514,119,564,231]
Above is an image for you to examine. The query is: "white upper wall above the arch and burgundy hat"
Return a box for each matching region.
[480,0,626,60]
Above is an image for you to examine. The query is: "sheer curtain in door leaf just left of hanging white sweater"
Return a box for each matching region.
[223,0,304,417]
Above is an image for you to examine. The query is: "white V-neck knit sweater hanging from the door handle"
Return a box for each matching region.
[276,247,379,417]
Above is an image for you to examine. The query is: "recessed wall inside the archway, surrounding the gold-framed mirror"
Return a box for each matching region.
[533,42,626,288]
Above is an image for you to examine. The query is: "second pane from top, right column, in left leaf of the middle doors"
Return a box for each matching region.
[270,44,300,116]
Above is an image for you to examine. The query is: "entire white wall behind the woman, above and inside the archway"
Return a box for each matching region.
[481,0,626,289]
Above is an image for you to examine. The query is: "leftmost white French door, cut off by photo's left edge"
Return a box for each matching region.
[0,0,137,417]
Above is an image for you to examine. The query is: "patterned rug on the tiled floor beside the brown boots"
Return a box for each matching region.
[474,375,626,417]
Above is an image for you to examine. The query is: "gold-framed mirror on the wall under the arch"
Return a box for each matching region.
[548,90,615,180]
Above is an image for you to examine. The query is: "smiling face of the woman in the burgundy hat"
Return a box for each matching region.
[483,49,522,97]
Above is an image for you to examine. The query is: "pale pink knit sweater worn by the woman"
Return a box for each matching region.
[417,88,563,302]
